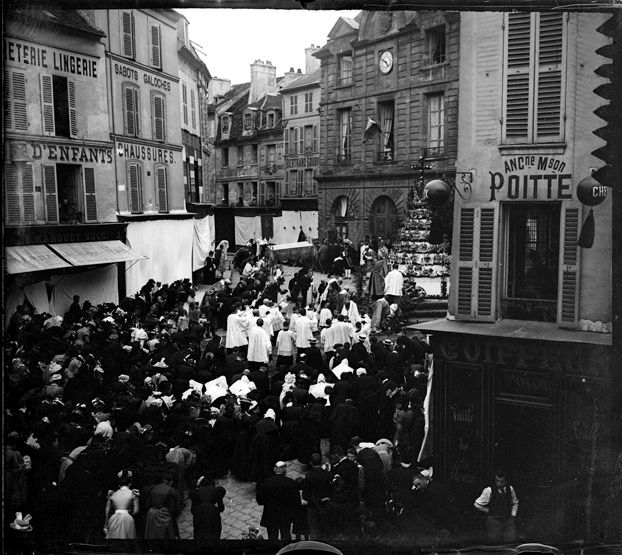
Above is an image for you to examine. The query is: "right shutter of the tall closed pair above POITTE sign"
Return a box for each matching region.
[536,12,564,140]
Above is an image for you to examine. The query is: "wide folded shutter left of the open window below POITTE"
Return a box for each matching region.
[455,204,498,322]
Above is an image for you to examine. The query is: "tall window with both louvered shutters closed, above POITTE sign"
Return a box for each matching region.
[503,12,565,144]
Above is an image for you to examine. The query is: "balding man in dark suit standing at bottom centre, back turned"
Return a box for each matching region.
[257,461,301,541]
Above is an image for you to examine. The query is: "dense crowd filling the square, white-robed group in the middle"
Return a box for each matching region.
[5,245,482,542]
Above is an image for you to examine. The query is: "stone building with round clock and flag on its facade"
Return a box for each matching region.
[315,11,459,244]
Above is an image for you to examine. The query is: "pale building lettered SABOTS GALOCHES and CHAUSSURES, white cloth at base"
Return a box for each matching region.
[94,9,198,294]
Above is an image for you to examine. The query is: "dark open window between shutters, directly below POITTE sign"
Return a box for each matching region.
[502,204,560,322]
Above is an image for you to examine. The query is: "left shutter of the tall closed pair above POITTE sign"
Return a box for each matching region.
[504,13,532,142]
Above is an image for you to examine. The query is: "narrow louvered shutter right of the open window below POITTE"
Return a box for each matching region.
[557,207,580,328]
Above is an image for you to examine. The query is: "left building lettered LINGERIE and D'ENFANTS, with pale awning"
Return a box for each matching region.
[3,8,138,317]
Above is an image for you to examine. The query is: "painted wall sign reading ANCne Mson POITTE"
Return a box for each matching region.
[488,154,572,202]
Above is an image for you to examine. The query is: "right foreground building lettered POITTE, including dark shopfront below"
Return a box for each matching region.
[416,12,617,541]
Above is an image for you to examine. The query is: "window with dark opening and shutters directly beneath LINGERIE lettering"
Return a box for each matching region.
[41,75,78,137]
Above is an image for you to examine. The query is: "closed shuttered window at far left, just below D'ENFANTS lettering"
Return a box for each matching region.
[4,163,41,225]
